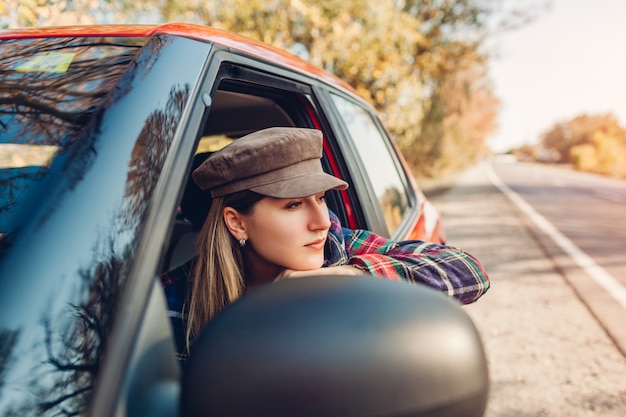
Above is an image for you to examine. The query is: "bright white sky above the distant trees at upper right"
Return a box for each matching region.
[488,0,626,152]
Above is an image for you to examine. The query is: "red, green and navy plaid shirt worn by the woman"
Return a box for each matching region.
[161,212,489,359]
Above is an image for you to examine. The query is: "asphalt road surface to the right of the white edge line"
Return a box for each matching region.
[493,158,626,292]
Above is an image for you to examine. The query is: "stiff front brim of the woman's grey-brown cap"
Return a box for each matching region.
[250,172,348,198]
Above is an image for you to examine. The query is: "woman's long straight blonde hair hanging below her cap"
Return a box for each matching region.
[183,191,264,350]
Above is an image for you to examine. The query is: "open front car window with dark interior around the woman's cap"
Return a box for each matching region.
[164,64,347,270]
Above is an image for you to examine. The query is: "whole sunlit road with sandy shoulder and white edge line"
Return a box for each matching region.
[424,161,626,417]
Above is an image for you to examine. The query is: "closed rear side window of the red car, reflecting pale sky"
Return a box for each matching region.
[331,94,410,234]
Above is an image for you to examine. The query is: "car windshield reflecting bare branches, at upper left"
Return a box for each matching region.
[0,37,147,254]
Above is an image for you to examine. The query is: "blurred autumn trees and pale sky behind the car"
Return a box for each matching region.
[0,0,626,180]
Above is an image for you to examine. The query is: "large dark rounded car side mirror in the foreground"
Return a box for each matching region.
[181,276,489,417]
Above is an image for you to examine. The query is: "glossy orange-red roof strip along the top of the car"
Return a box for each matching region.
[0,23,356,95]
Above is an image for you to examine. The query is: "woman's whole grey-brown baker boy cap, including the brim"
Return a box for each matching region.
[192,127,348,198]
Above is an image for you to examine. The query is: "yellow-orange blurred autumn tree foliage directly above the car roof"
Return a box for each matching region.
[0,0,524,177]
